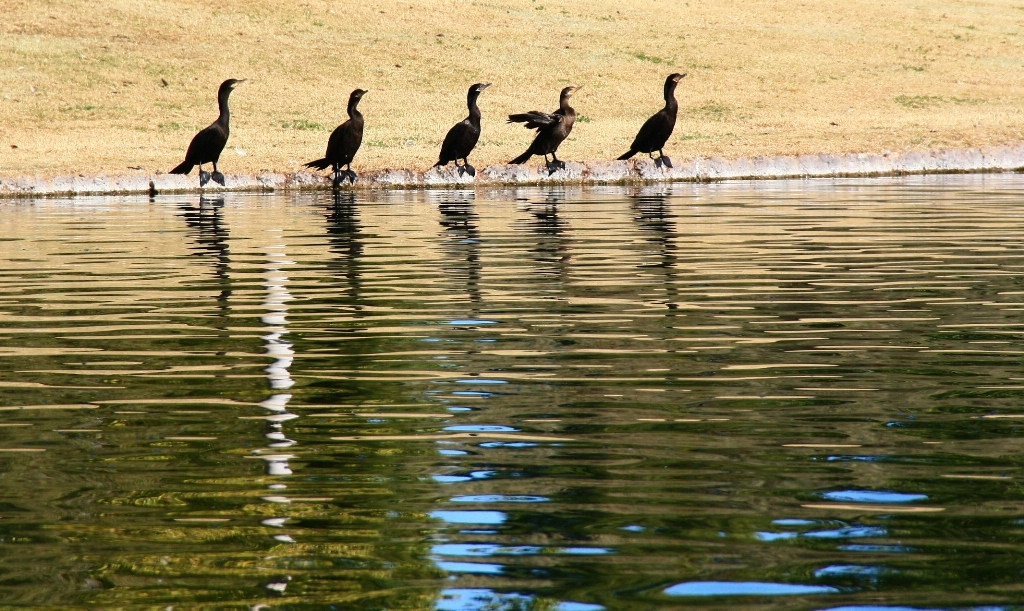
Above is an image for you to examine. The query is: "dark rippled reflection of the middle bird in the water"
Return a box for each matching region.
[437,191,483,318]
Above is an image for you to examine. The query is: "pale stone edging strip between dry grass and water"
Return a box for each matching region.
[0,142,1024,198]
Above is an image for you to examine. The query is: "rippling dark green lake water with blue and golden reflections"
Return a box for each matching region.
[0,175,1024,611]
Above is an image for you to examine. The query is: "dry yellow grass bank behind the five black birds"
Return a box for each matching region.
[0,0,1024,176]
